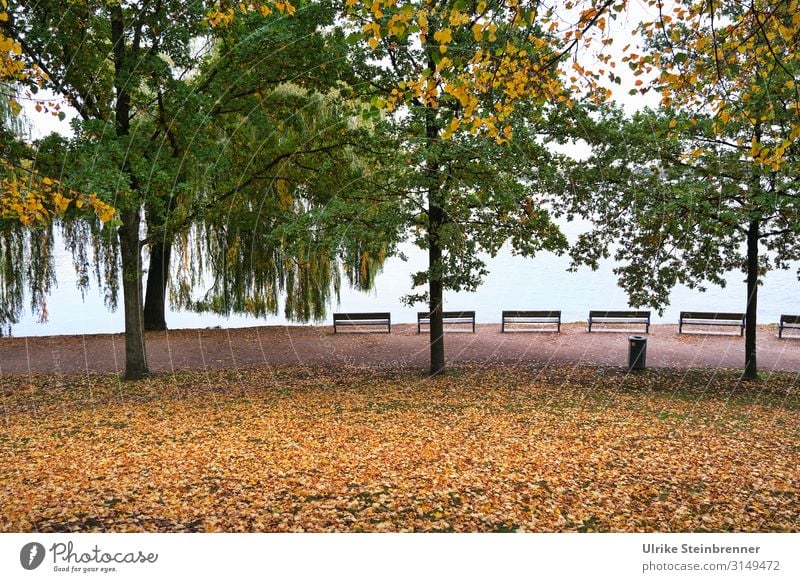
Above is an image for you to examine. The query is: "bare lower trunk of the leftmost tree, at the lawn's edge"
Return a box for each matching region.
[117,210,149,380]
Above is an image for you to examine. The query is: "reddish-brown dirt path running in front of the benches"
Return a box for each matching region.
[0,323,800,374]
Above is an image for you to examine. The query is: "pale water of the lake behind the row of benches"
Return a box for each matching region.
[11,224,800,337]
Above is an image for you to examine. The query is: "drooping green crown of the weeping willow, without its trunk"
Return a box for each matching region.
[146,2,392,328]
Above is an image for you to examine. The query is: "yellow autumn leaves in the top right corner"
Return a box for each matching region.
[624,0,800,171]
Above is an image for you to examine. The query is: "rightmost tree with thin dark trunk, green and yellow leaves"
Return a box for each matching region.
[573,2,800,379]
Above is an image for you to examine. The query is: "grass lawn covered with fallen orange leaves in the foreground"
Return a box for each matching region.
[0,367,800,532]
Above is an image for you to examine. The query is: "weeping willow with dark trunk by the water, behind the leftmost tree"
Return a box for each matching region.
[138,2,396,329]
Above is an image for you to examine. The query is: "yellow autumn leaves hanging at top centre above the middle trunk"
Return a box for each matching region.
[345,0,625,143]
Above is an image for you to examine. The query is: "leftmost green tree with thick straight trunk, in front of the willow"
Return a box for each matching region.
[2,1,239,379]
